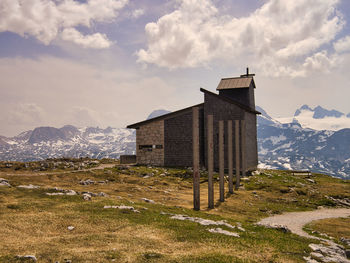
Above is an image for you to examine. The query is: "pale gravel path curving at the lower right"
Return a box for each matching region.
[258,208,350,238]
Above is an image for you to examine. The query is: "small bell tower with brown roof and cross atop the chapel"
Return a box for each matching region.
[216,68,255,110]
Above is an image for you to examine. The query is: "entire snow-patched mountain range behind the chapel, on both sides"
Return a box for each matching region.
[0,105,350,179]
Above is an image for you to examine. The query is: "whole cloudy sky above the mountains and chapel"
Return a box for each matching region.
[0,0,350,136]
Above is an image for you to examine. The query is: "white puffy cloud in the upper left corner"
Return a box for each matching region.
[0,0,128,48]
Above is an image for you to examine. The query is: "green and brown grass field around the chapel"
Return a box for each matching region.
[0,162,350,262]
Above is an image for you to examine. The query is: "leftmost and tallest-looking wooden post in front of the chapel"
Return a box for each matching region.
[192,107,200,210]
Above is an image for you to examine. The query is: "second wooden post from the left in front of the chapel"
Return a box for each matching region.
[207,115,214,208]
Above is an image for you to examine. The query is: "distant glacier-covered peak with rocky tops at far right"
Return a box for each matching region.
[277,105,350,131]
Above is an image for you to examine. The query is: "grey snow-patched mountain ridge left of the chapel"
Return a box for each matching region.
[0,125,136,161]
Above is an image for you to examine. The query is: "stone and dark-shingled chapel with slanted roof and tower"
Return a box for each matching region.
[127,68,260,171]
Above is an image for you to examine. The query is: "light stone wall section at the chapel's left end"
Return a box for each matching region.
[136,120,164,166]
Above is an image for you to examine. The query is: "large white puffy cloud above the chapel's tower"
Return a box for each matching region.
[137,0,345,76]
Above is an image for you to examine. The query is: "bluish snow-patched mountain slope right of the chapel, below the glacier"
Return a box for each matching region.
[258,108,350,179]
